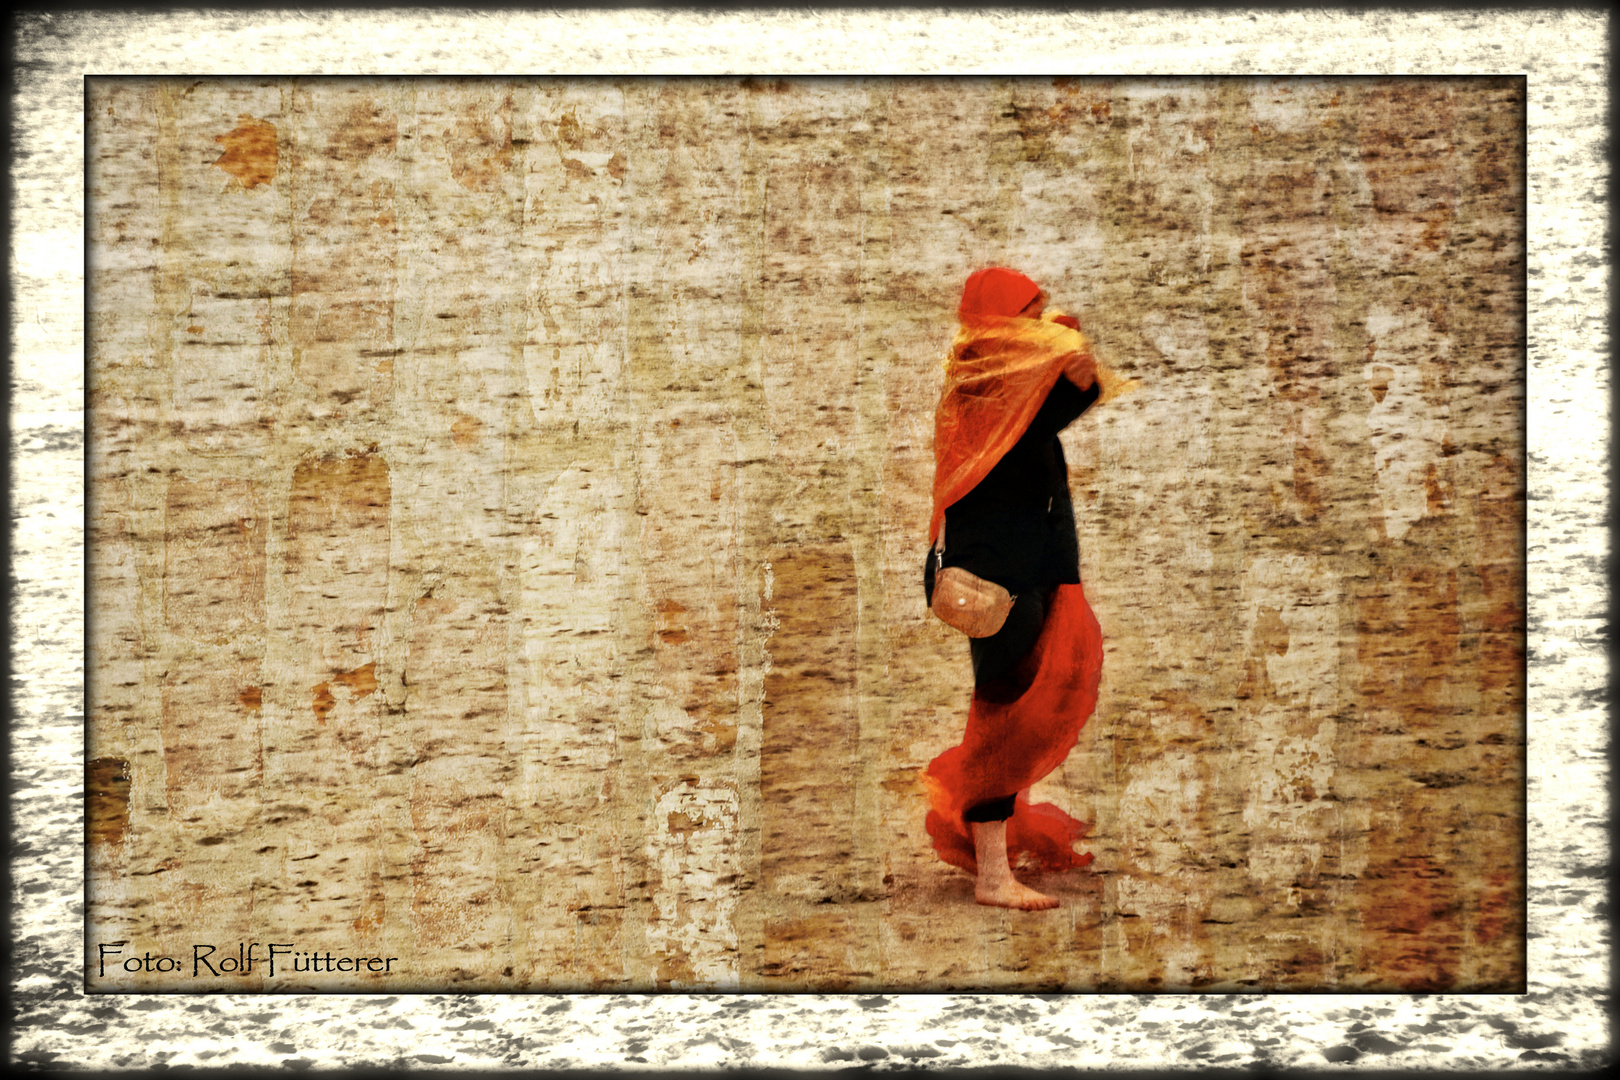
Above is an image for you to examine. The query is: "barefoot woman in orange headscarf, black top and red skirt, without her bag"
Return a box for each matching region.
[923,267,1132,910]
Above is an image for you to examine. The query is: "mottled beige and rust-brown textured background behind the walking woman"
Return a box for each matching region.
[87,78,1524,991]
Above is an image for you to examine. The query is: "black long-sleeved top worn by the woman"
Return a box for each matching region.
[923,376,1102,602]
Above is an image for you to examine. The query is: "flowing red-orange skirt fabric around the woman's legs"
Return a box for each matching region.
[925,585,1103,873]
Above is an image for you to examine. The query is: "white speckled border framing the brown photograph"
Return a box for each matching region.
[10,11,1609,1070]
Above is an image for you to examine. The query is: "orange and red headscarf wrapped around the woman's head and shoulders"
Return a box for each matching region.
[928,267,1134,544]
